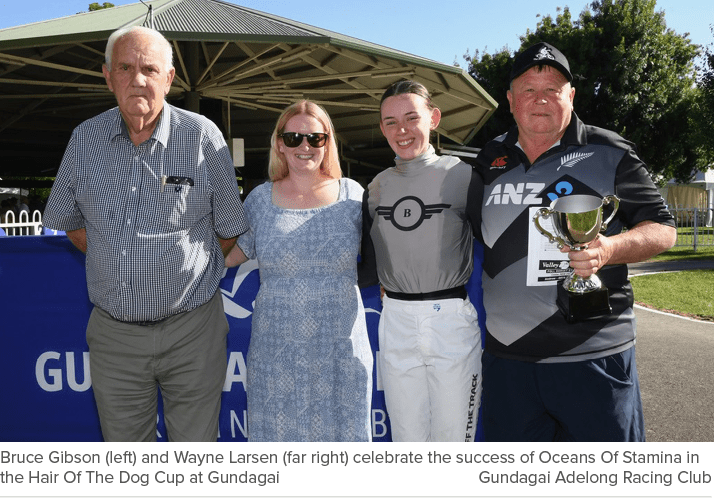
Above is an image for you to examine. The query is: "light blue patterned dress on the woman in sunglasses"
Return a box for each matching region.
[238,178,373,442]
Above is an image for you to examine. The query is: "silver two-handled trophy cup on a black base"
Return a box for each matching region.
[533,194,620,321]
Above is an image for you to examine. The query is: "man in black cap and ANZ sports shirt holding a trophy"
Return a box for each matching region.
[467,43,677,441]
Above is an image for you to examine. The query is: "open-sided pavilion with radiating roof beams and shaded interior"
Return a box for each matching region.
[0,0,496,190]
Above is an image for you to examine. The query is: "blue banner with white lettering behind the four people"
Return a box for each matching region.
[0,236,485,442]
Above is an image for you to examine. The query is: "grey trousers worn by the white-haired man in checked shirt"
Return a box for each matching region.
[87,291,228,442]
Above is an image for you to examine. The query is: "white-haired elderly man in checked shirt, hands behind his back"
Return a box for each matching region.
[45,27,247,441]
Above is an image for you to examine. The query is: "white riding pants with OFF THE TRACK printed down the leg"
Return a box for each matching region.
[379,295,482,442]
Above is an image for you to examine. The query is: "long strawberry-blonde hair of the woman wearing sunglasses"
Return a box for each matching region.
[268,100,342,182]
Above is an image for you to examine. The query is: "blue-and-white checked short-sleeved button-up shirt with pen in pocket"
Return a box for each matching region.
[44,103,248,322]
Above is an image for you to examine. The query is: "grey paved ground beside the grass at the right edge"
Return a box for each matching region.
[628,262,714,442]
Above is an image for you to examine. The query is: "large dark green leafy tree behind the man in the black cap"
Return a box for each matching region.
[467,0,714,184]
